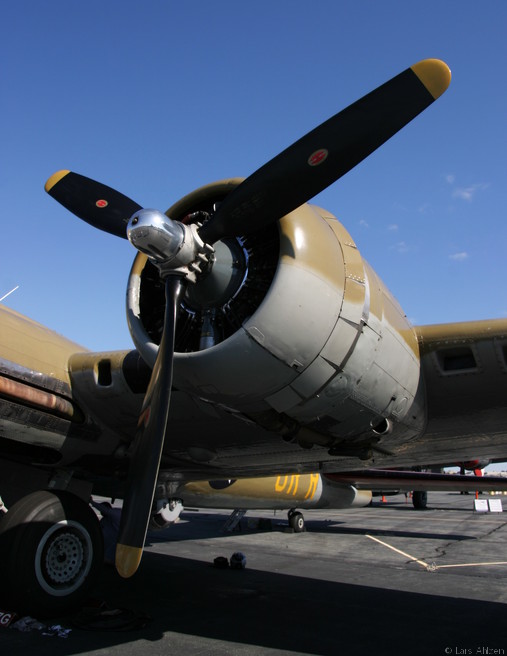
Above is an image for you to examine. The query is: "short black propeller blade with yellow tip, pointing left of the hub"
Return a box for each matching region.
[44,171,141,239]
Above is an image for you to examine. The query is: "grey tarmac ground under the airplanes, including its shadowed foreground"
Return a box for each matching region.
[0,493,507,656]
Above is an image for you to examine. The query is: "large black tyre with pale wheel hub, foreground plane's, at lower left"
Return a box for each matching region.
[0,491,104,616]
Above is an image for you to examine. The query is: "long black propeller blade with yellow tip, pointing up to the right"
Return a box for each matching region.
[199,59,451,244]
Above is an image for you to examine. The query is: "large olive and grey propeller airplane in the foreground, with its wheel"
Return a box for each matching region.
[0,60,507,612]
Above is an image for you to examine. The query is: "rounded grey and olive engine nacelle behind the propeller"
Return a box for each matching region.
[127,180,425,457]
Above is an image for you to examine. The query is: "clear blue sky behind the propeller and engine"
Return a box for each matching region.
[0,0,507,358]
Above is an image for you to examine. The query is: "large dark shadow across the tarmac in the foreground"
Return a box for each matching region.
[0,552,506,656]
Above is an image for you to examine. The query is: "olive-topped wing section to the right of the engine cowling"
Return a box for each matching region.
[398,319,507,464]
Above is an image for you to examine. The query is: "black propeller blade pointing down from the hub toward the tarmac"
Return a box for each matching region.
[116,275,183,578]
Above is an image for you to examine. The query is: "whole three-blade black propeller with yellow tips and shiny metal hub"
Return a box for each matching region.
[46,59,451,577]
